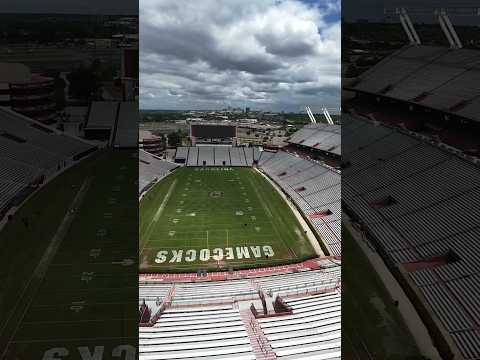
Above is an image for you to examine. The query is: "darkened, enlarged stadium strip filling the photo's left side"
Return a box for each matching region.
[0,1,138,359]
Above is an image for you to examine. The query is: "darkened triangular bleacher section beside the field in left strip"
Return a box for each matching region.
[0,108,93,213]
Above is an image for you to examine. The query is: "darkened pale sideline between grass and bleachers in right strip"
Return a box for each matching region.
[342,212,441,359]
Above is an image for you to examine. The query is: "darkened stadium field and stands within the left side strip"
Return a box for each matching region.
[0,102,138,360]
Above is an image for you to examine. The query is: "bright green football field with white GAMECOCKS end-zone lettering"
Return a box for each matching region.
[139,167,315,272]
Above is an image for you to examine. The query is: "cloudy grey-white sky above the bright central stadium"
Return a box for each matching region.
[140,0,341,111]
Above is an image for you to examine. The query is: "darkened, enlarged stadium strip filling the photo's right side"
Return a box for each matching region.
[342,0,480,359]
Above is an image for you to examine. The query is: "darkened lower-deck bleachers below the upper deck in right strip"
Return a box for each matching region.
[342,115,480,359]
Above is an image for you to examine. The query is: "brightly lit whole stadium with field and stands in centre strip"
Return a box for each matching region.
[139,123,341,359]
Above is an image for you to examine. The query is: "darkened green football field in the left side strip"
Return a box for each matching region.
[0,150,138,360]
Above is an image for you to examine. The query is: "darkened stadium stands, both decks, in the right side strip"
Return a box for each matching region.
[342,8,480,359]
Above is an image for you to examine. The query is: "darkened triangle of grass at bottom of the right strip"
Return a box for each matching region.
[342,228,423,360]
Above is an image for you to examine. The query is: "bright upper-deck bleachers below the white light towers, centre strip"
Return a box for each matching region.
[288,123,342,155]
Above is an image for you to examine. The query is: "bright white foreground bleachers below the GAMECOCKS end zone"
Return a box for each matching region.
[139,266,341,360]
